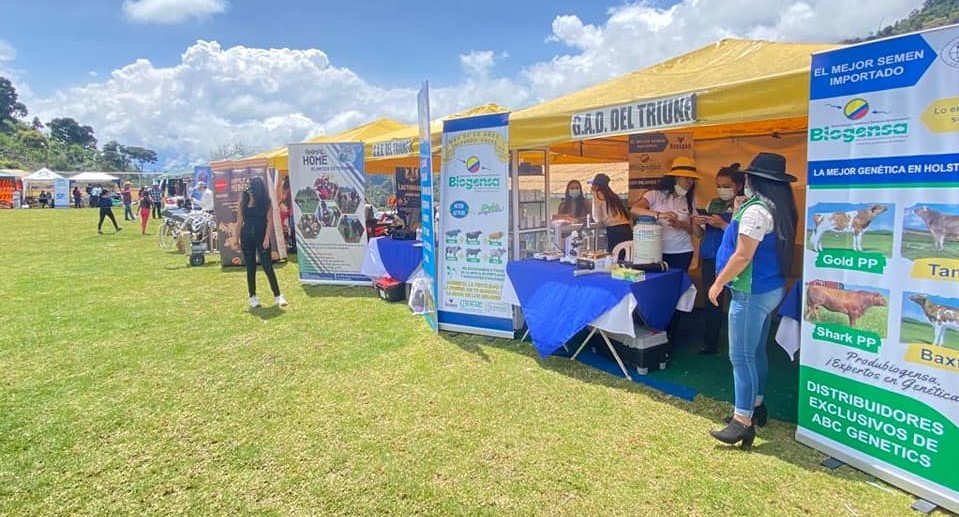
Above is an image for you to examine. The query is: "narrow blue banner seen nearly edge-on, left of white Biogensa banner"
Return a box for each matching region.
[416,82,439,332]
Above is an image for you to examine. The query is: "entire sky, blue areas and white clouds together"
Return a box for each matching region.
[0,0,922,170]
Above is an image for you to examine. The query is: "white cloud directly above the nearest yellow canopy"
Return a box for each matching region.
[522,0,921,99]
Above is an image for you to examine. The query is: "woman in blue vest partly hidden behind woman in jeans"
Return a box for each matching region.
[693,163,746,355]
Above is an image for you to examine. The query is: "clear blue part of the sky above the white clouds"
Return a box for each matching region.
[0,0,616,95]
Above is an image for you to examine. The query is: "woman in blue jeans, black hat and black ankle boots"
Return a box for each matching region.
[709,153,798,449]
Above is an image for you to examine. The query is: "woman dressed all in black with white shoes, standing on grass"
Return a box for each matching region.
[236,176,287,309]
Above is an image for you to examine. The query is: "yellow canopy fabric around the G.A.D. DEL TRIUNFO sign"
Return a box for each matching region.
[509,39,837,160]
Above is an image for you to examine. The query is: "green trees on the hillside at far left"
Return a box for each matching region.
[0,77,157,172]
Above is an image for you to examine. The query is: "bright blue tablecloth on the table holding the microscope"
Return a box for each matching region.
[506,260,692,356]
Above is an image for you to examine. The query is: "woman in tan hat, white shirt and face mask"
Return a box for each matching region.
[632,156,703,271]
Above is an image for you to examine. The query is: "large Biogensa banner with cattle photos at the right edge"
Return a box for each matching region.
[796,26,959,511]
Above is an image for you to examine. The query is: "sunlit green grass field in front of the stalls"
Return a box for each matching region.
[0,210,944,516]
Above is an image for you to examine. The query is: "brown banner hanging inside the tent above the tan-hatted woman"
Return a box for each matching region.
[629,133,693,204]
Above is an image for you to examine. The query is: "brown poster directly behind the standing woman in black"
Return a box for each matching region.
[212,168,281,266]
